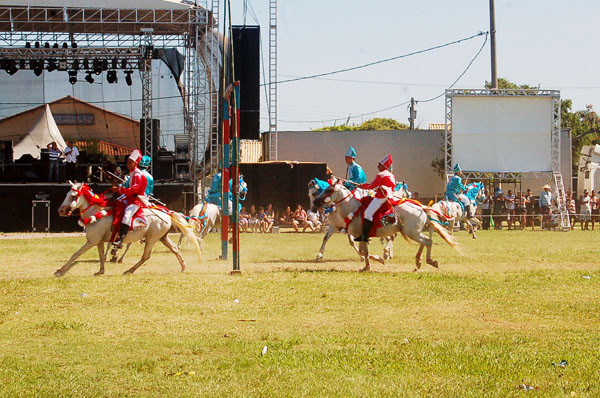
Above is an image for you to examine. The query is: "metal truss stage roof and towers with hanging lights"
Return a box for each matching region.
[0,0,221,193]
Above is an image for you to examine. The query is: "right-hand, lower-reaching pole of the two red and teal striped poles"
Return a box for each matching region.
[231,80,240,272]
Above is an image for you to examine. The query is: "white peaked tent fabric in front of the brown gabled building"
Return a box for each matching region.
[13,104,67,159]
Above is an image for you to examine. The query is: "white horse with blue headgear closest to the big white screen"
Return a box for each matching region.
[430,182,484,239]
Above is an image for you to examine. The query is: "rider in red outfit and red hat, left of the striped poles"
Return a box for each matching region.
[112,149,147,248]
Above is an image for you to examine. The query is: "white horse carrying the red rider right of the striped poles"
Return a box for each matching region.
[311,177,458,271]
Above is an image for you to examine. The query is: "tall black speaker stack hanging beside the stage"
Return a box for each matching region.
[233,25,260,140]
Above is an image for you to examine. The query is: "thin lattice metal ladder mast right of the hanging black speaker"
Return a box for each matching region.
[268,0,277,161]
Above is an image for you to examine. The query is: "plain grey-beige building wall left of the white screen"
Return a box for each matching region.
[277,130,445,198]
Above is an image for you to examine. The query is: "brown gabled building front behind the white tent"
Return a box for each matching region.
[0,101,140,148]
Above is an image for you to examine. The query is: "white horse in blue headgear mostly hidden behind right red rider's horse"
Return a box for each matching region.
[308,178,409,264]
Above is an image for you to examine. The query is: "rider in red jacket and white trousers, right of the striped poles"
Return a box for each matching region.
[355,153,396,243]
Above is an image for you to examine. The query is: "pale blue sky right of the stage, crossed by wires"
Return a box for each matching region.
[232,0,600,131]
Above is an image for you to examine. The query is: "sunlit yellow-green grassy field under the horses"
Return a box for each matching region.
[0,231,600,397]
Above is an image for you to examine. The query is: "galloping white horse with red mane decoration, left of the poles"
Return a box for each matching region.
[54,181,202,277]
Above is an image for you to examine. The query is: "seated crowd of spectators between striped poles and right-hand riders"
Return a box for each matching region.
[240,203,327,233]
